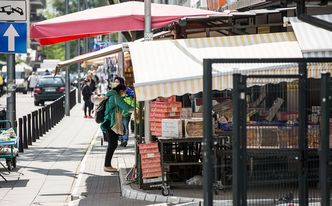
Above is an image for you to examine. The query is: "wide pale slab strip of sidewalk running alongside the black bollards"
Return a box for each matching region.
[0,104,98,206]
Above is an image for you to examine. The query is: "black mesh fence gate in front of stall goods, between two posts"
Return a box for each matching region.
[232,70,308,205]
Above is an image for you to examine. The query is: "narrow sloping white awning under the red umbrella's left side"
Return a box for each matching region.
[57,44,122,69]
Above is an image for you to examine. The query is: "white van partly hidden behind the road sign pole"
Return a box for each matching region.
[1,63,32,94]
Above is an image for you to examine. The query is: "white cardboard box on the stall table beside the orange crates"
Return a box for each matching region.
[161,119,183,138]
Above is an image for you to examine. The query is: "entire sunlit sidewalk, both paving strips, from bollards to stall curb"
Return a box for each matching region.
[0,104,197,206]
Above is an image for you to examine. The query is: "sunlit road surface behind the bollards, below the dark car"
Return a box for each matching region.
[0,93,50,119]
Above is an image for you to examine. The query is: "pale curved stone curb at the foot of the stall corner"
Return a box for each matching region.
[119,168,203,206]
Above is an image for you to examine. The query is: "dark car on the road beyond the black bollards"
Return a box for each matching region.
[34,75,65,106]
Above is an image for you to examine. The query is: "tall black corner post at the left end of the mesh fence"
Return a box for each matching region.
[203,59,214,206]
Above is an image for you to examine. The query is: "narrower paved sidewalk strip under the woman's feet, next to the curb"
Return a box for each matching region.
[70,132,152,206]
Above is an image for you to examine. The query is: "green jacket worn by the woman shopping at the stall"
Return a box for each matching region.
[100,90,131,132]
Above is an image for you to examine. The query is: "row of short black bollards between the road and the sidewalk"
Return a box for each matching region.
[18,89,76,152]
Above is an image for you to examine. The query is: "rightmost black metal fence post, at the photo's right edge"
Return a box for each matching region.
[319,73,332,206]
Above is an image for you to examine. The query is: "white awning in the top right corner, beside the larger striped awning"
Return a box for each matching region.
[289,14,332,57]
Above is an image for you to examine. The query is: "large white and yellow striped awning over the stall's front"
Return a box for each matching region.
[129,32,302,101]
